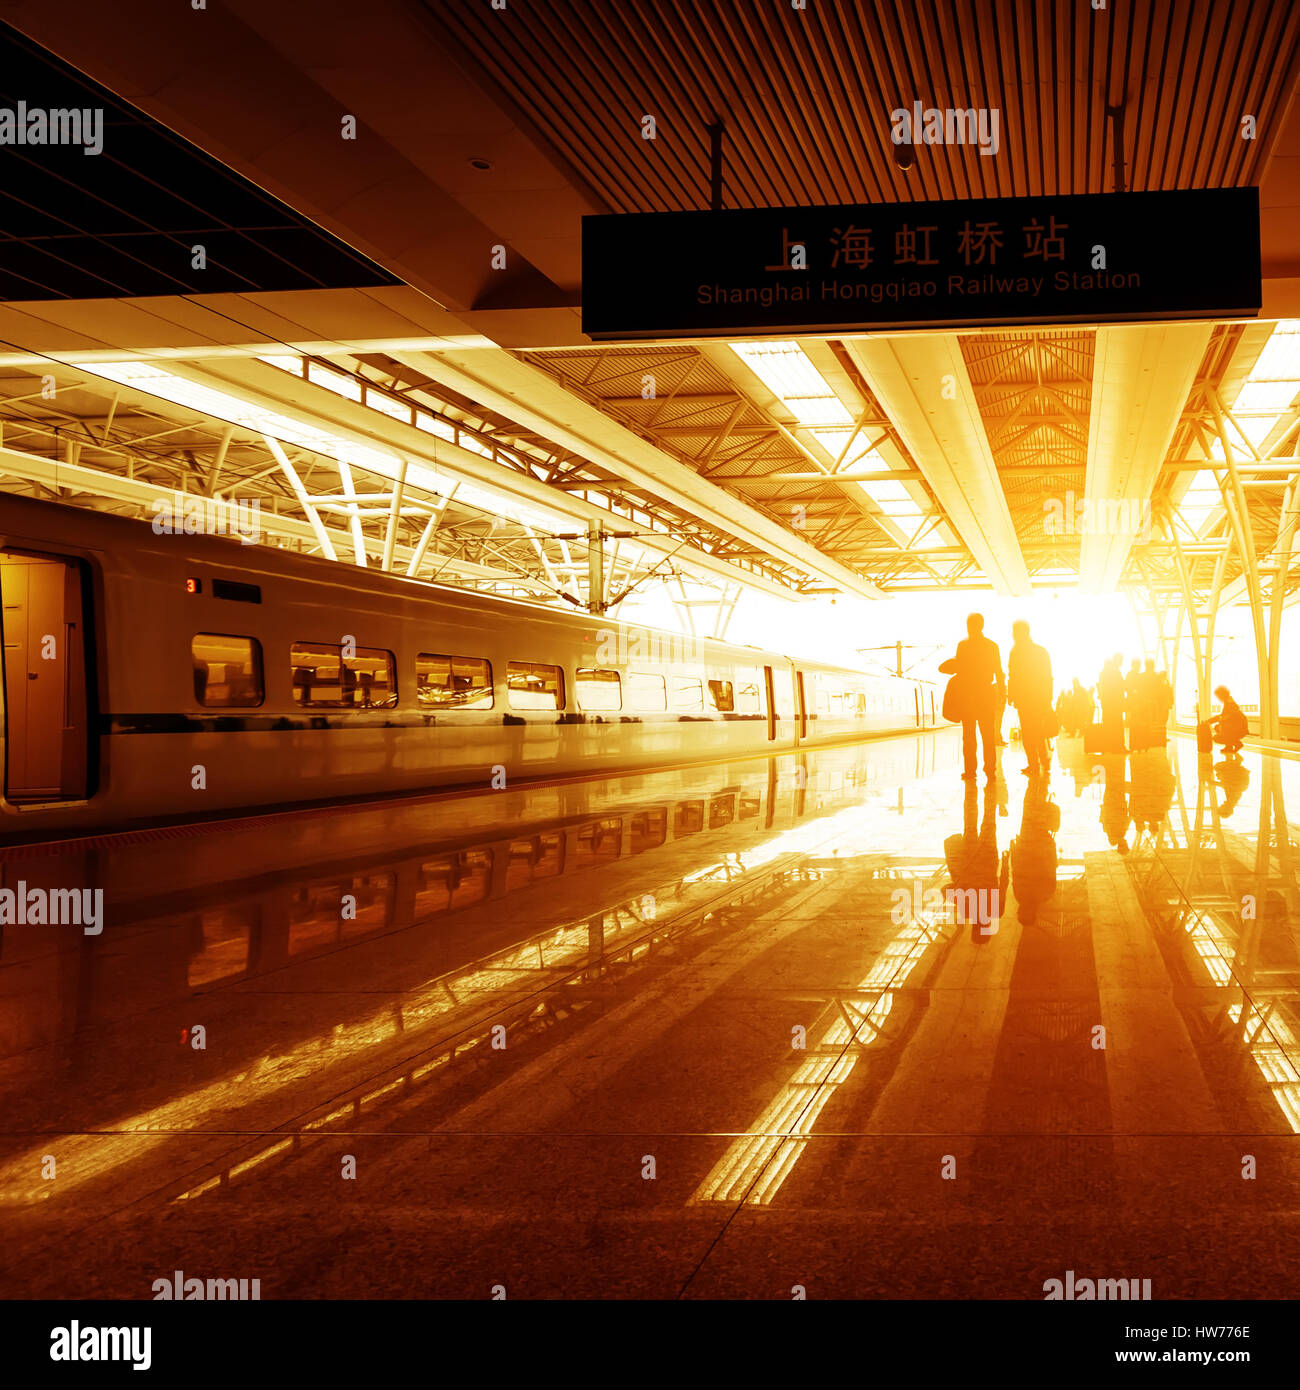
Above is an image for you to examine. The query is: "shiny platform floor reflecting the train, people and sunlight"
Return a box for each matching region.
[0,731,1300,1300]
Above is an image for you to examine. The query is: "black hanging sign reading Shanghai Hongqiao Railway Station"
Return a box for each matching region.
[583,188,1261,339]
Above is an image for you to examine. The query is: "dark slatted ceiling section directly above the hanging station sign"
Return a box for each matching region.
[425,0,1300,211]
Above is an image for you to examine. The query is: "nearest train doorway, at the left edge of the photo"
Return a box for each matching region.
[0,550,90,802]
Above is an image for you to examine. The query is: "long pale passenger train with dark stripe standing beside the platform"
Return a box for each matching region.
[0,498,936,838]
